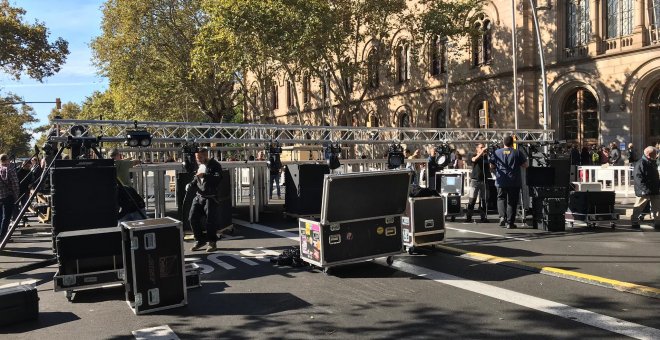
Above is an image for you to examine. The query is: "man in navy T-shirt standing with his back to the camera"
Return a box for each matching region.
[490,136,528,229]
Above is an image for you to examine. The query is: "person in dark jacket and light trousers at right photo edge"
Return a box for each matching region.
[630,146,660,229]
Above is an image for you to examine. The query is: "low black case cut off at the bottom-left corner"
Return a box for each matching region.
[0,284,39,327]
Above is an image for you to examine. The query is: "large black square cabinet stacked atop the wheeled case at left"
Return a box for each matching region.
[50,159,119,235]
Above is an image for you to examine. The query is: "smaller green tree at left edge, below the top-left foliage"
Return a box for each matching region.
[0,94,37,156]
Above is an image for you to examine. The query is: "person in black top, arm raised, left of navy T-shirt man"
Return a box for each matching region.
[465,143,488,223]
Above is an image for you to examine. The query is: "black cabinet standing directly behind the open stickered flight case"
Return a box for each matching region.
[284,164,330,216]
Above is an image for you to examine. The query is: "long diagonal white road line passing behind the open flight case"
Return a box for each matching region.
[235,220,660,339]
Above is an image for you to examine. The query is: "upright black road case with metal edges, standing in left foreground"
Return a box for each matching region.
[122,217,187,314]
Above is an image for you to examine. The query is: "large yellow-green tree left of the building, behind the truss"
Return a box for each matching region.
[91,0,236,122]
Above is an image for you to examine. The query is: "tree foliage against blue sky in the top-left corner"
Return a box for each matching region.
[0,0,69,81]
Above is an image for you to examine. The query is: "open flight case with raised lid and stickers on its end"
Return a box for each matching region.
[298,170,412,272]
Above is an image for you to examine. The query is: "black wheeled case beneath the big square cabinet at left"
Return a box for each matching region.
[53,227,124,301]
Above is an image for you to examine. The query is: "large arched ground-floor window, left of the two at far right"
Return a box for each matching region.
[561,88,600,146]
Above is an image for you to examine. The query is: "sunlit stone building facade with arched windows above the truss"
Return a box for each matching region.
[247,0,660,149]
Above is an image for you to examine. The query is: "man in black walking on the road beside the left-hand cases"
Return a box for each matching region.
[189,148,222,253]
